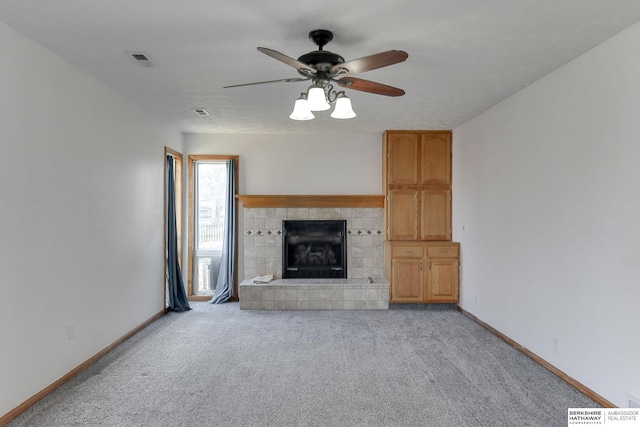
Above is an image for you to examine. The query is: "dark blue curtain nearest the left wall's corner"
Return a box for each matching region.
[167,156,191,311]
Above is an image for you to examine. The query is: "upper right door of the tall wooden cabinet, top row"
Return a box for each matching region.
[420,133,451,185]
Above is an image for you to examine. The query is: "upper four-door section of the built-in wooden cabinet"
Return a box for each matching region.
[383,131,451,240]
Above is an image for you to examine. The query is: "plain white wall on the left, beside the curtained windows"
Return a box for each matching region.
[0,23,182,416]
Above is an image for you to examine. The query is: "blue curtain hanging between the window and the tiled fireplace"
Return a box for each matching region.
[209,159,236,304]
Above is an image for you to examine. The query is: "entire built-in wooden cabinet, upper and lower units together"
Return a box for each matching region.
[383,130,460,303]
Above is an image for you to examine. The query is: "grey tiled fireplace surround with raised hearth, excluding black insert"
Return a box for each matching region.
[239,207,389,310]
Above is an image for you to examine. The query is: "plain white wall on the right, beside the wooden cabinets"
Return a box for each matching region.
[453,24,640,406]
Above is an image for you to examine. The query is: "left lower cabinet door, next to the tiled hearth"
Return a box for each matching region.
[391,258,424,302]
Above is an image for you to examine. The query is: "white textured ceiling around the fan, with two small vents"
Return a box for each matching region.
[0,0,640,133]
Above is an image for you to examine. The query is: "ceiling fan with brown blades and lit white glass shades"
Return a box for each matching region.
[224,30,409,120]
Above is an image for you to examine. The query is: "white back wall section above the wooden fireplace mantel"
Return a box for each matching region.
[184,133,382,194]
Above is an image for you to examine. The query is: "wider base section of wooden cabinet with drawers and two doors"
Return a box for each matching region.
[385,241,460,303]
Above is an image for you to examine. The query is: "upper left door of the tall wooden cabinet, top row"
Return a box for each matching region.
[387,132,420,185]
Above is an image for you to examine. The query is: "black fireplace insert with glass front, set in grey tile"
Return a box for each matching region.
[282,220,347,279]
